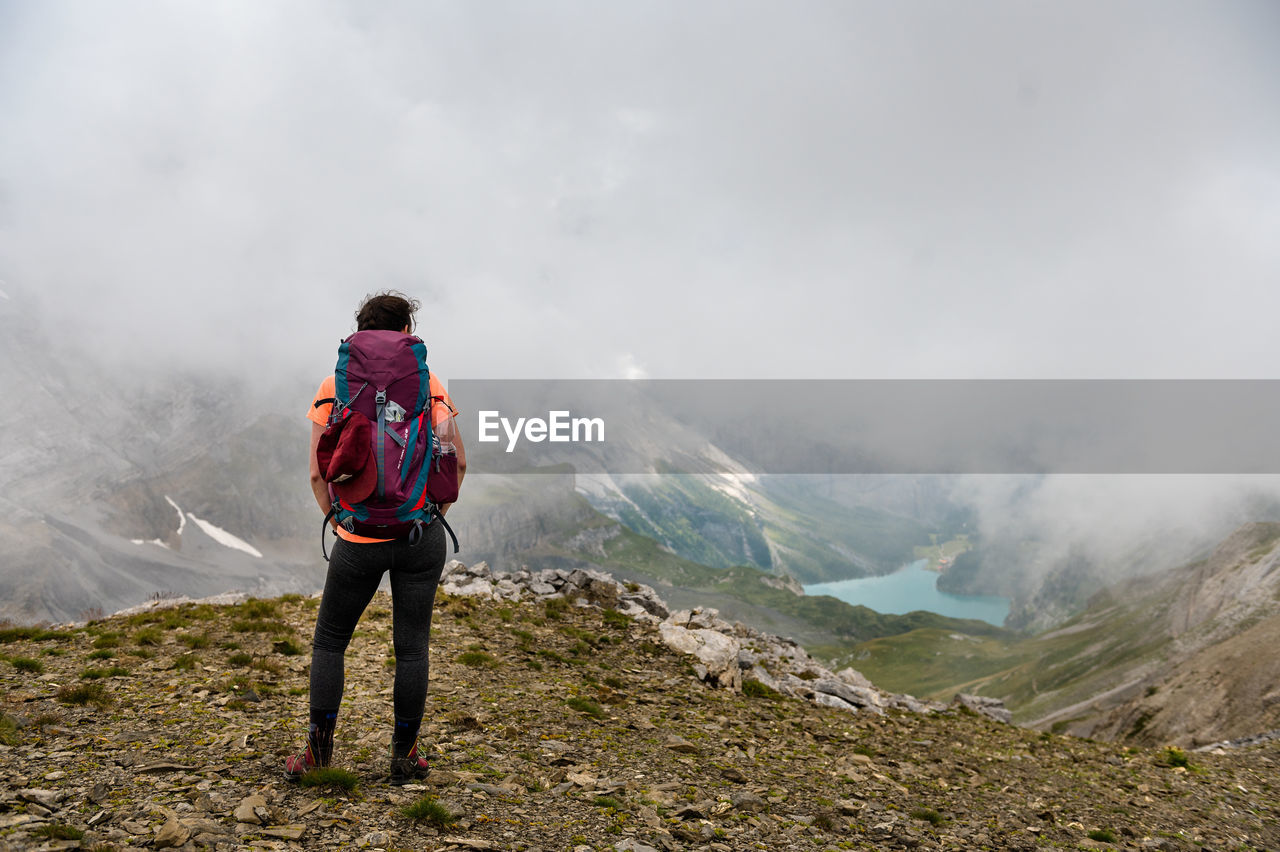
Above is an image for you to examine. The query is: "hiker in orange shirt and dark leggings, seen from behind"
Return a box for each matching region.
[284,292,466,785]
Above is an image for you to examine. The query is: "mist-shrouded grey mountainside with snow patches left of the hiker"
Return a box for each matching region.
[0,281,325,620]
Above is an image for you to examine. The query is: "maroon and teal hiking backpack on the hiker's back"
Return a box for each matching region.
[316,330,458,558]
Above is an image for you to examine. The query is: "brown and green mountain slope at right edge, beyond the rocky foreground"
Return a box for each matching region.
[854,523,1280,745]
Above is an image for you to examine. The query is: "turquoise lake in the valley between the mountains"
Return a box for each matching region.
[804,559,1009,626]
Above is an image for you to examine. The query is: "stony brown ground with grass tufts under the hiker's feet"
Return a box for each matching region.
[0,560,1280,851]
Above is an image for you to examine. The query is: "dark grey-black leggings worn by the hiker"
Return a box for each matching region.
[311,523,445,728]
